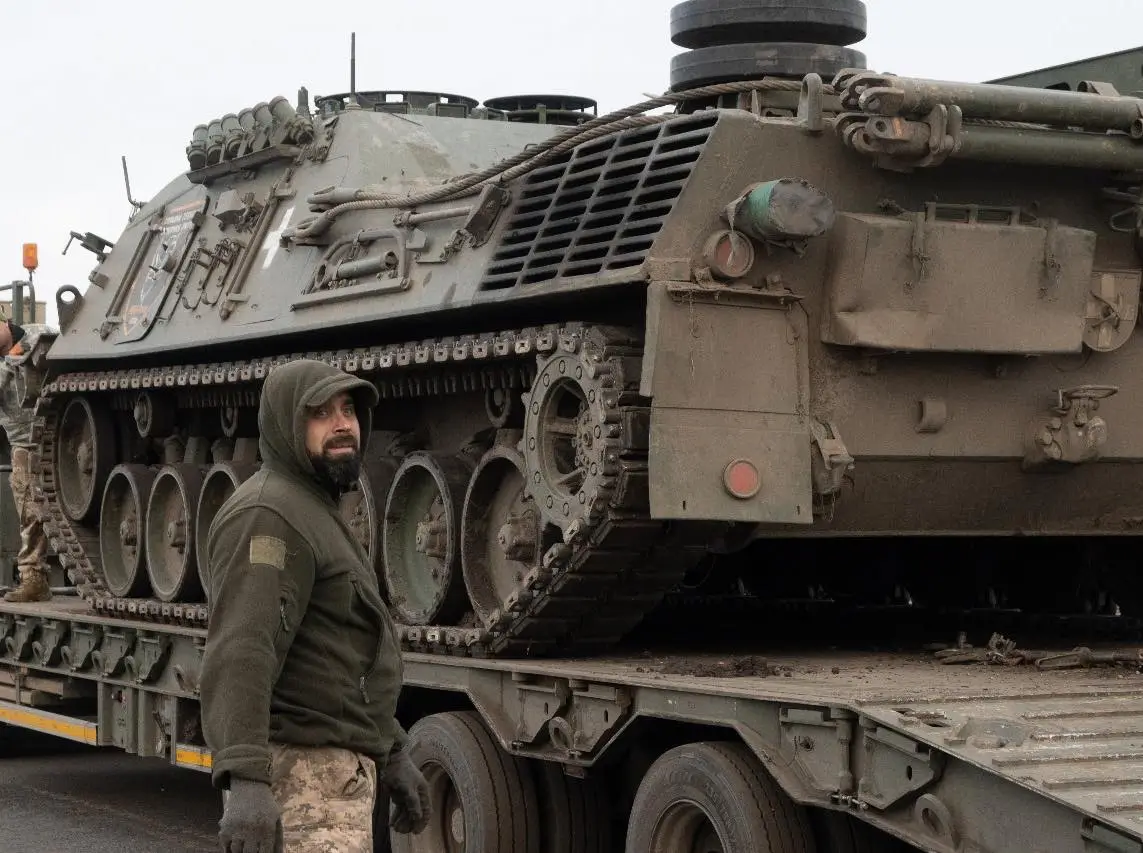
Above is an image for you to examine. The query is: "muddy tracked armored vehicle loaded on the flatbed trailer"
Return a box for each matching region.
[29,21,1143,655]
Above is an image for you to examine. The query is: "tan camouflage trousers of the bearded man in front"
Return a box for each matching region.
[270,743,377,853]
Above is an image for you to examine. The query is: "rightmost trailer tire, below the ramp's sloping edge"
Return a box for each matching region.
[625,742,817,853]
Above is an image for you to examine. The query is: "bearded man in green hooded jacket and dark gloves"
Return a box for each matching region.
[200,360,429,853]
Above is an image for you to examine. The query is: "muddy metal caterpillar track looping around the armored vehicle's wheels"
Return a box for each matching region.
[38,324,704,656]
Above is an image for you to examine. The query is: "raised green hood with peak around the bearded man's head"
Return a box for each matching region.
[258,359,379,479]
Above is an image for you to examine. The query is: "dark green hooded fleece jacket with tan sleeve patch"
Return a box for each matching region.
[200,360,407,788]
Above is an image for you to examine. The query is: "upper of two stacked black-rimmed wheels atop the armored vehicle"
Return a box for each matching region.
[671,0,868,48]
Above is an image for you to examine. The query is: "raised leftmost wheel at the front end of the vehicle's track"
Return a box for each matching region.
[55,397,115,524]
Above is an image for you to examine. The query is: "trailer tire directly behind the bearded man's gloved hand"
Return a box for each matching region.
[390,711,541,853]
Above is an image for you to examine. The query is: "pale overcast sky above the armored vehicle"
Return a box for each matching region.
[0,0,1143,322]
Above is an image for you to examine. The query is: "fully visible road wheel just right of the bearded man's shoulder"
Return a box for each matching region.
[382,452,472,625]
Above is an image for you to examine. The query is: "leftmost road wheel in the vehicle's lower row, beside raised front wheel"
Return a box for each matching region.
[99,465,155,598]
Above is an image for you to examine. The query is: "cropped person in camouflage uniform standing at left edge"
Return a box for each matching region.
[0,320,53,601]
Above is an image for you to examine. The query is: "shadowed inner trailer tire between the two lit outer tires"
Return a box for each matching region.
[531,760,614,853]
